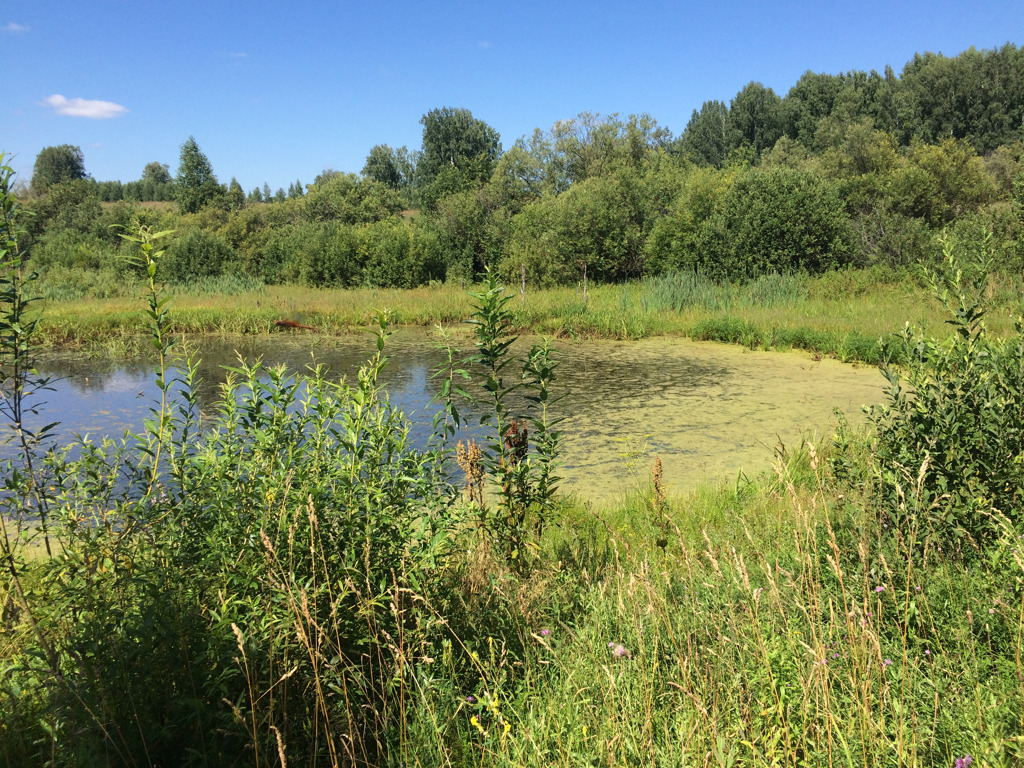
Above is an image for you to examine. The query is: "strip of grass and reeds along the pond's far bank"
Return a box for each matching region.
[32,270,1024,364]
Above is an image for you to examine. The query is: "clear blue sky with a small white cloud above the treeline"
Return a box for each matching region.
[0,0,1024,190]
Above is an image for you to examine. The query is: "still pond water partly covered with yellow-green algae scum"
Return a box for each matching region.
[19,329,883,501]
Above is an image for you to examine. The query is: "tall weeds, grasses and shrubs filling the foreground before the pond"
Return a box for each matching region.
[0,151,1024,766]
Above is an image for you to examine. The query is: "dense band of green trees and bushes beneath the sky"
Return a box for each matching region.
[14,43,1024,298]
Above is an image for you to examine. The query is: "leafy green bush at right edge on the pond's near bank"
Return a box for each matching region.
[871,239,1024,547]
